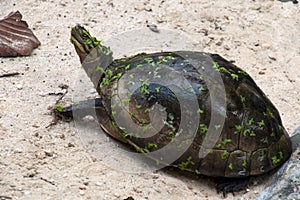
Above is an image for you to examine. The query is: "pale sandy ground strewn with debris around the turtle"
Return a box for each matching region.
[0,0,300,200]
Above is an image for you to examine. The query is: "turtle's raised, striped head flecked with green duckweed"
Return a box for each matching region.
[70,25,112,63]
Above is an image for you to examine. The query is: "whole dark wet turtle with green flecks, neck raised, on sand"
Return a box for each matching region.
[57,25,292,195]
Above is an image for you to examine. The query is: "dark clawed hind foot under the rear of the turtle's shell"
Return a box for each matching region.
[216,178,250,198]
